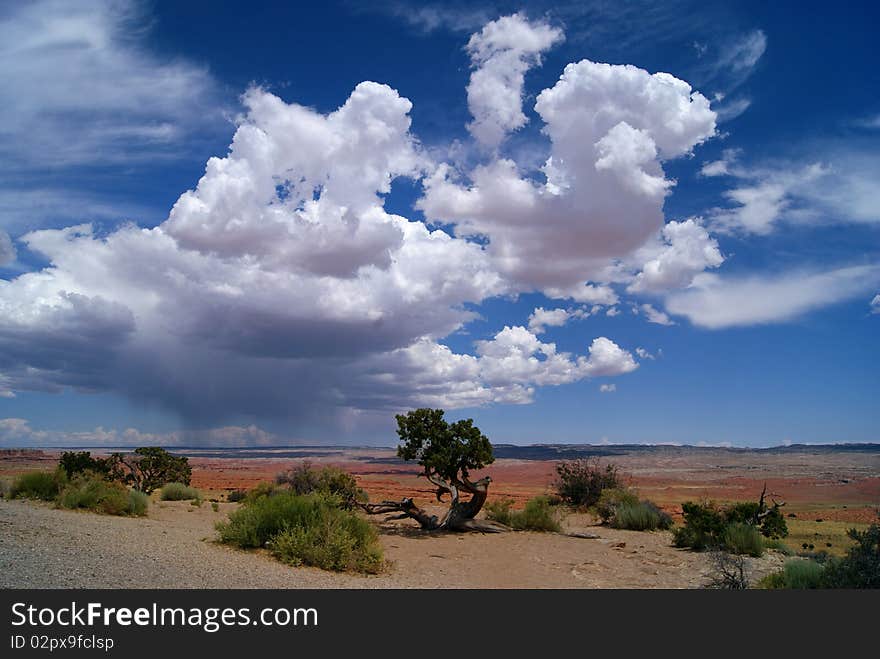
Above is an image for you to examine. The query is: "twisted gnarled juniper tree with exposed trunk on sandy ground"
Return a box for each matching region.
[360,408,507,533]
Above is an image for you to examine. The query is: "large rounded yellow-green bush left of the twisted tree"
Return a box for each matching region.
[217,490,382,572]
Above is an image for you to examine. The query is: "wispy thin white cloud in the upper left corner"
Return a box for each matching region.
[0,0,221,173]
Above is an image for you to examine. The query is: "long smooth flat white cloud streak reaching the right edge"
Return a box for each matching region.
[666,266,880,329]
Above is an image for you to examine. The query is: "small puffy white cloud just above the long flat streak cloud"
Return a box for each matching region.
[627,218,724,292]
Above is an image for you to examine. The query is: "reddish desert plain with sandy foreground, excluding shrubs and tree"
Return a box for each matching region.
[0,445,880,588]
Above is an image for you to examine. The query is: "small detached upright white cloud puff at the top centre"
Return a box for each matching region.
[467,14,563,148]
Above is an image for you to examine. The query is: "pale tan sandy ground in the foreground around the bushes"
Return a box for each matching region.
[0,501,783,588]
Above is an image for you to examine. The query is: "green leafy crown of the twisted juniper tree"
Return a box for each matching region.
[395,408,495,482]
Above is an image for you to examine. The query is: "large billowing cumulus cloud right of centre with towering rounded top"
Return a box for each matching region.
[418,60,715,296]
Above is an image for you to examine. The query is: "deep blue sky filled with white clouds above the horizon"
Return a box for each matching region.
[0,0,880,446]
